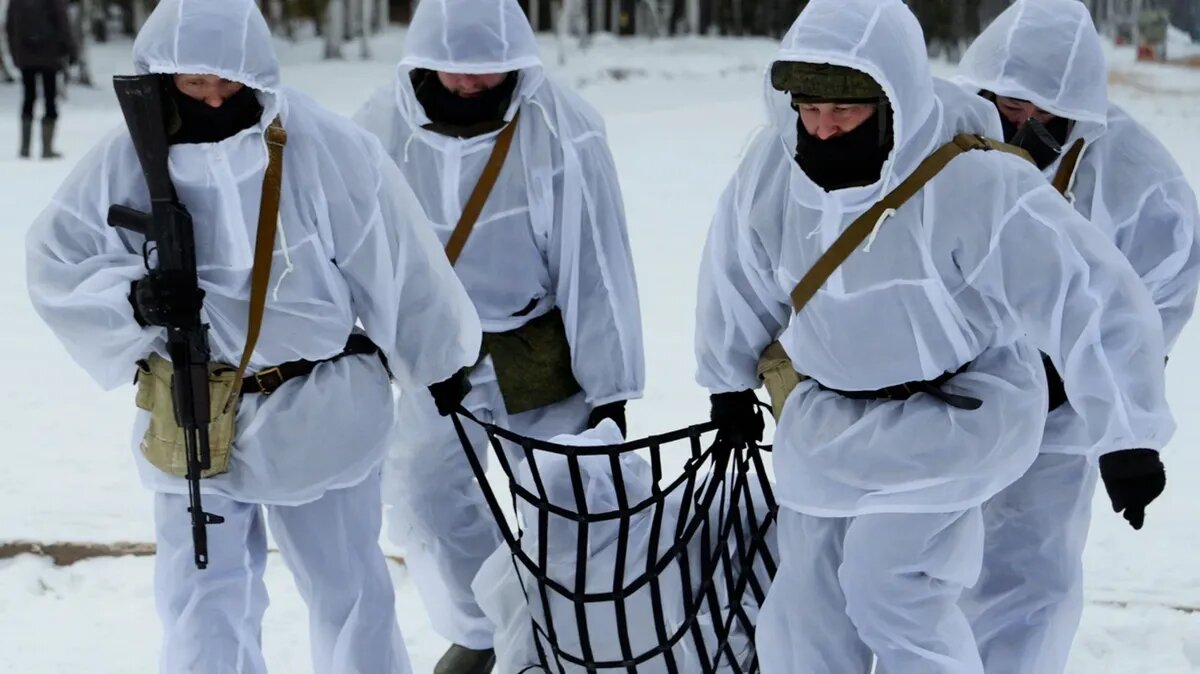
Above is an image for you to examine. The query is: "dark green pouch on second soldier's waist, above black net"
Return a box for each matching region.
[484,308,582,414]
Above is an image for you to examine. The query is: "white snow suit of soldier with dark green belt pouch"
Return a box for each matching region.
[355,0,644,649]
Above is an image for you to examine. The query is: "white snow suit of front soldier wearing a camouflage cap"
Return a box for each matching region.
[696,0,1174,674]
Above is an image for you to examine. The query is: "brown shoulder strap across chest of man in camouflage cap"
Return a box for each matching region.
[792,133,1033,313]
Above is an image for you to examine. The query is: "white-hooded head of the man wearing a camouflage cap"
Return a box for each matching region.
[767,0,936,204]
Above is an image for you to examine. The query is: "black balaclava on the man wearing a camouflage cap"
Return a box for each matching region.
[796,106,894,192]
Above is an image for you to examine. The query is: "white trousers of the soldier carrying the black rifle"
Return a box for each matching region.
[155,471,412,674]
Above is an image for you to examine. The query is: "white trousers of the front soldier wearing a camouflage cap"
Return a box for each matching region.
[755,508,984,674]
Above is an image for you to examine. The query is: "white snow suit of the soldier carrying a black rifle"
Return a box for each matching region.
[28,0,480,674]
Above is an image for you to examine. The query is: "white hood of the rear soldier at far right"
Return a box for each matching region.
[954,0,1109,137]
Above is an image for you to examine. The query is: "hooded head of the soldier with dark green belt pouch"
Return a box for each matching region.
[397,0,544,130]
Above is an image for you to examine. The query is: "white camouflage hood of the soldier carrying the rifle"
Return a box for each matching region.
[133,0,280,94]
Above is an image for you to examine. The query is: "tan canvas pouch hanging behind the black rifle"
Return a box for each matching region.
[137,354,241,477]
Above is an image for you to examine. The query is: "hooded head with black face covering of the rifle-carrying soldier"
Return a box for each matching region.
[133,0,280,143]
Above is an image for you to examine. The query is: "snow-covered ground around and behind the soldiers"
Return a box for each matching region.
[0,27,1200,674]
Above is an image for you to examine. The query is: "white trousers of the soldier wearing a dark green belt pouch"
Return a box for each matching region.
[385,361,590,649]
